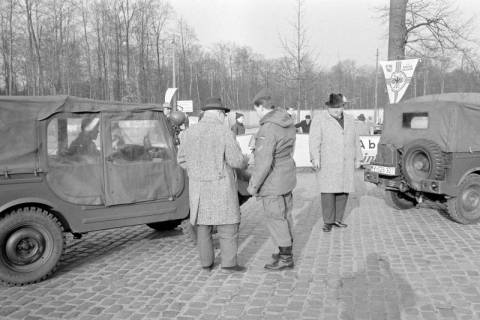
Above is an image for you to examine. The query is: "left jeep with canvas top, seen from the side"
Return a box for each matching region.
[0,96,189,285]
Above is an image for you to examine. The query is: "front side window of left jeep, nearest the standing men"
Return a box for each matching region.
[108,119,173,162]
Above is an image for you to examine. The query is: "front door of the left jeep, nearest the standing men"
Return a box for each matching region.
[103,111,184,206]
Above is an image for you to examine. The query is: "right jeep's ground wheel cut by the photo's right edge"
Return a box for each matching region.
[447,174,480,224]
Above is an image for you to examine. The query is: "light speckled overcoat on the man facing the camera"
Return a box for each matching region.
[309,111,362,193]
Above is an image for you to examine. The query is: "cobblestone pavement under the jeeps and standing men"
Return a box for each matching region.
[0,172,480,320]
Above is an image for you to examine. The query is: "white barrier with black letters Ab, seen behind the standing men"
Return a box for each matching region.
[237,134,380,167]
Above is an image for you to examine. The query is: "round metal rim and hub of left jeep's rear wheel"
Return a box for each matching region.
[5,227,45,266]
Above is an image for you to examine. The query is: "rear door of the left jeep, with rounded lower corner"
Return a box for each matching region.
[47,113,105,205]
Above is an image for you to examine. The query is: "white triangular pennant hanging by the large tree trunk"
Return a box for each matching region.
[380,59,419,103]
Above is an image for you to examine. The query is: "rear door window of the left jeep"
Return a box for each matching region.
[47,115,101,163]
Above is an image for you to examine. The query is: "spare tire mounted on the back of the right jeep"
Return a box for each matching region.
[401,139,445,182]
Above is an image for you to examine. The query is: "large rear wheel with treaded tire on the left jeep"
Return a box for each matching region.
[0,207,65,285]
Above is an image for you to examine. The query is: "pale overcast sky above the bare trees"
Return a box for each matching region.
[170,0,480,67]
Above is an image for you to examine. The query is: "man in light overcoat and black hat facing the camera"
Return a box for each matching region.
[309,93,361,232]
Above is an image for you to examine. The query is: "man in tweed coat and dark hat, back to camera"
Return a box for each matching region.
[177,98,247,272]
